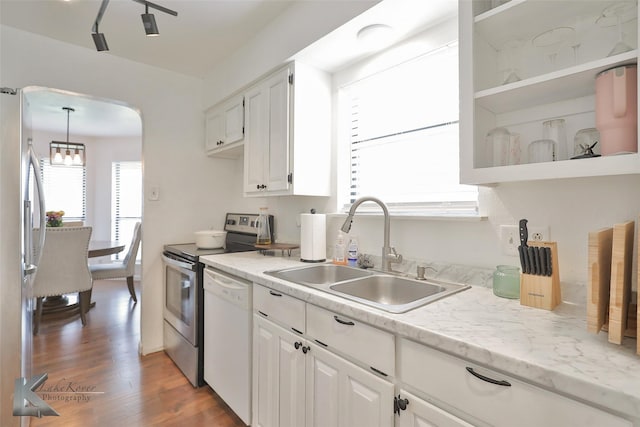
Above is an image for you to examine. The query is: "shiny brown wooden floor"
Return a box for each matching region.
[31,280,245,427]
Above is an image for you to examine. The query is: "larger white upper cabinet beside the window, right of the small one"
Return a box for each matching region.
[244,63,331,196]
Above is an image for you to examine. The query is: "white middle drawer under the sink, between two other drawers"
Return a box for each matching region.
[307,304,395,376]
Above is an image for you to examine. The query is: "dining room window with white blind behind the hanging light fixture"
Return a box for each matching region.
[40,158,87,222]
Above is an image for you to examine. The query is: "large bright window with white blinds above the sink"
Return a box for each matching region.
[342,43,478,215]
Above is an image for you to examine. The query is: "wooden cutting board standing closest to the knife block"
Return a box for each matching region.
[587,228,613,334]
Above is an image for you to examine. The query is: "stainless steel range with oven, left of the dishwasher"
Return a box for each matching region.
[162,213,274,387]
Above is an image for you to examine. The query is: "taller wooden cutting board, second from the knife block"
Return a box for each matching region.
[609,221,635,344]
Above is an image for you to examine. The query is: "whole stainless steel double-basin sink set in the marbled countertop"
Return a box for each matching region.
[265,264,469,313]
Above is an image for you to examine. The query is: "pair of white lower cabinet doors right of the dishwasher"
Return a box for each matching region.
[253,314,393,427]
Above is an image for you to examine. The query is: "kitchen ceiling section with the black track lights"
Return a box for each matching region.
[0,0,292,77]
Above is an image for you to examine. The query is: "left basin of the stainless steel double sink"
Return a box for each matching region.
[265,264,373,286]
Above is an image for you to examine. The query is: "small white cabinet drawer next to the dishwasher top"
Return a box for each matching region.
[253,283,305,334]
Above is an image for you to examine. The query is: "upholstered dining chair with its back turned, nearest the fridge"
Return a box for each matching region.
[33,227,93,335]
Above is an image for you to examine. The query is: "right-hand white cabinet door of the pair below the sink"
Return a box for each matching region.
[306,344,394,427]
